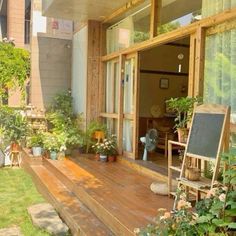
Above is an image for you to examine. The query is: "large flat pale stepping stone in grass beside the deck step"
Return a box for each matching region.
[28,203,69,235]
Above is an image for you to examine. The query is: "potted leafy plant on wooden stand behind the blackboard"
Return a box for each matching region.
[166,97,200,143]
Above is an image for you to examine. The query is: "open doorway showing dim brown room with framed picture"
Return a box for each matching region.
[138,37,190,168]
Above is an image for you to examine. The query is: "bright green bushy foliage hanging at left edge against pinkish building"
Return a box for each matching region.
[0,39,30,102]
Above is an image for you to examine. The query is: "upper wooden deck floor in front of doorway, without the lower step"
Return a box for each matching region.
[44,157,173,232]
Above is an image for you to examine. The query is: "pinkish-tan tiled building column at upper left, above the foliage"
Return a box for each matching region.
[7,0,25,48]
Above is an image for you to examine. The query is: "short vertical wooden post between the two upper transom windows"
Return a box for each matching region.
[150,0,161,39]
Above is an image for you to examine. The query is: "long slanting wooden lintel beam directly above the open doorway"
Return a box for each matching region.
[102,8,236,61]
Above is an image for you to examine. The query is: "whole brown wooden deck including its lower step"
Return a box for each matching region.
[21,152,173,236]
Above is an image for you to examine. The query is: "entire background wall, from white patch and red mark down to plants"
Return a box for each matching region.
[30,0,73,109]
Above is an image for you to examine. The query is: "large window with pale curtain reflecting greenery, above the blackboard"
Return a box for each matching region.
[204,26,236,144]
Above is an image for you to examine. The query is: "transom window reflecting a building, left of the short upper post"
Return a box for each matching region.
[107,0,151,53]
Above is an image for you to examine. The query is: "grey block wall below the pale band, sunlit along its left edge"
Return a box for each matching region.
[30,37,71,109]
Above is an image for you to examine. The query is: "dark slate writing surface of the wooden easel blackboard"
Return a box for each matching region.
[187,113,225,158]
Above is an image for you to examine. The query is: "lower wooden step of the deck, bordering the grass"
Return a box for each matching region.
[32,166,113,236]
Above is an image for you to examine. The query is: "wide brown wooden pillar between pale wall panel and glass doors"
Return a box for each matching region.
[86,21,101,123]
